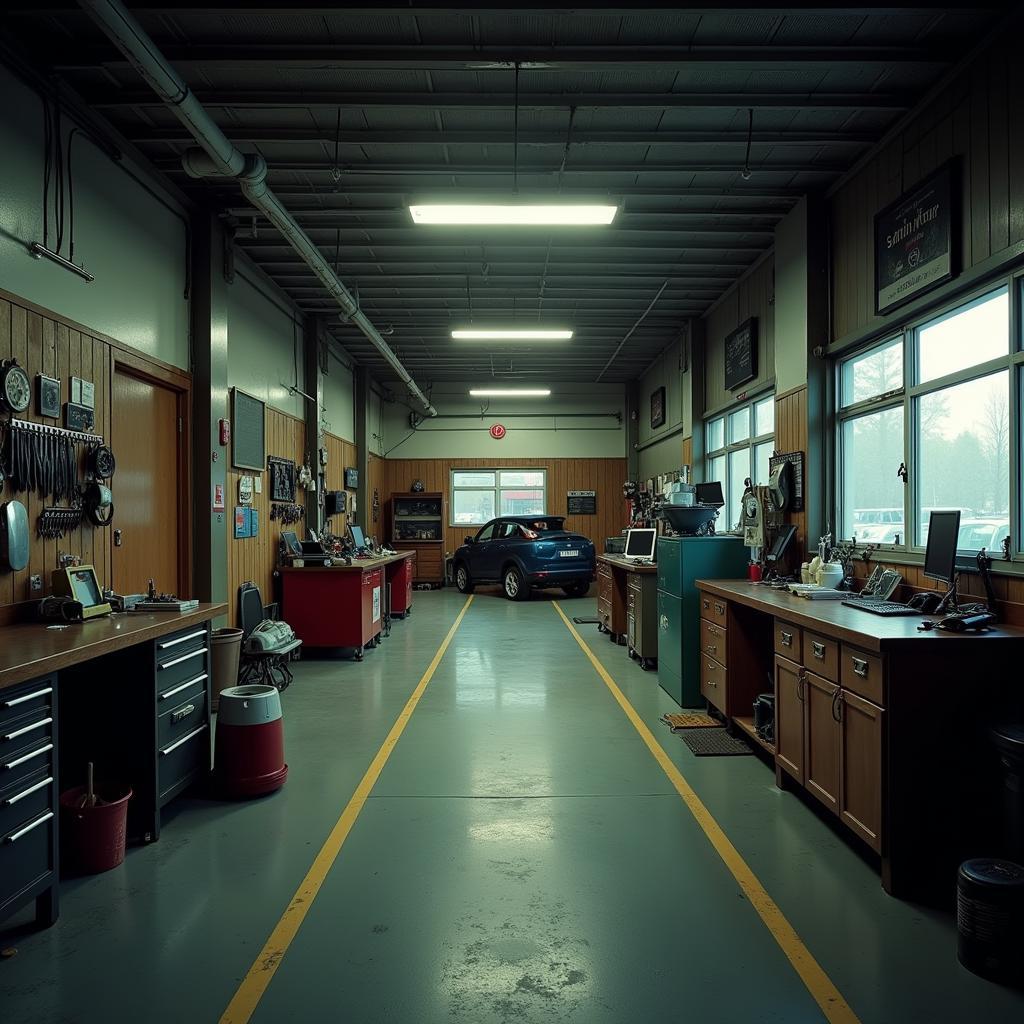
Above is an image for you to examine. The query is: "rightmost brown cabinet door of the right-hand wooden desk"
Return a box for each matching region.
[838,690,886,853]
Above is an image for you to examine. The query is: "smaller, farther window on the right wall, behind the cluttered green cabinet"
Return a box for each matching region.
[705,395,775,525]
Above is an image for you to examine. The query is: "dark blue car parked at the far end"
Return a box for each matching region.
[453,515,596,601]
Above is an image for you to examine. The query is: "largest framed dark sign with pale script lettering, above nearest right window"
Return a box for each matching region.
[874,161,955,314]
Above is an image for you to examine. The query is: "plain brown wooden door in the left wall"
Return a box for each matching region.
[111,367,186,596]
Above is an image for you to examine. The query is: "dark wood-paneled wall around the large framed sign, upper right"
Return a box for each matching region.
[829,34,1024,340]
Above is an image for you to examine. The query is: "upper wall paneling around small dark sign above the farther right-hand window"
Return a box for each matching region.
[694,254,775,419]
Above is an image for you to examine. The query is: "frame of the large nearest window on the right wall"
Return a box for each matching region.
[829,276,1024,572]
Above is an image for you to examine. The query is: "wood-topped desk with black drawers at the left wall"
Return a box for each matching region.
[0,604,227,925]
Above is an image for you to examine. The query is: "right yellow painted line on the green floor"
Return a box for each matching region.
[554,601,859,1024]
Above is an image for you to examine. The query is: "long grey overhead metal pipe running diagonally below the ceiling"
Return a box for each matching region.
[80,0,437,416]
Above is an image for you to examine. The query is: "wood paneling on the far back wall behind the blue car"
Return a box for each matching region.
[382,459,626,552]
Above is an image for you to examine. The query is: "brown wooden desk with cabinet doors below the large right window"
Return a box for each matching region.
[697,580,1024,901]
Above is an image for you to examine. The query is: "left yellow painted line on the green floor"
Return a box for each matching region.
[220,597,473,1024]
